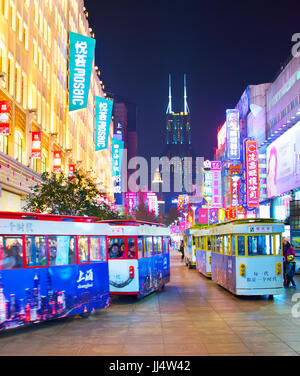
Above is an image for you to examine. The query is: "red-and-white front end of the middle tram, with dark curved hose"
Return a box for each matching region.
[107,236,139,294]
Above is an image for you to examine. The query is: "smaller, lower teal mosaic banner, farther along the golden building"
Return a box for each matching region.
[95,97,114,151]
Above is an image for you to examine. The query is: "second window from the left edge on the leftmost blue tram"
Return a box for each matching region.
[26,236,47,266]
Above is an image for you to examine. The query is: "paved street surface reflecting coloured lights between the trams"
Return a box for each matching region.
[0,252,300,356]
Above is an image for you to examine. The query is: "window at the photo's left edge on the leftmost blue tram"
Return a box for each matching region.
[0,236,23,269]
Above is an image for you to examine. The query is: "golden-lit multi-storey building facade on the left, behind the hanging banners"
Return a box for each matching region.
[0,0,113,211]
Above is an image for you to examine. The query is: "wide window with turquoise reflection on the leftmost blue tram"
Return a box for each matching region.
[48,236,76,266]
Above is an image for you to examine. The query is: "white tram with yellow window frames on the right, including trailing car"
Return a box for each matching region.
[185,219,284,295]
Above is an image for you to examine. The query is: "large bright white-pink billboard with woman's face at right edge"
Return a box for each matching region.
[267,122,300,198]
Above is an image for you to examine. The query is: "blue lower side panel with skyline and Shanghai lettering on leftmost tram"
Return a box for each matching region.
[0,262,110,330]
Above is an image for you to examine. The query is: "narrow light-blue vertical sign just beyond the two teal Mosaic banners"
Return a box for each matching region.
[111,138,124,205]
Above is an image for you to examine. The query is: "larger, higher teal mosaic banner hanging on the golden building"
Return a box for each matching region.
[69,32,96,111]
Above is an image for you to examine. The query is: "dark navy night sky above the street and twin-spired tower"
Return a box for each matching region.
[85,0,300,158]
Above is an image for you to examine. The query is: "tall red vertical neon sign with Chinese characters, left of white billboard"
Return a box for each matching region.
[245,140,259,208]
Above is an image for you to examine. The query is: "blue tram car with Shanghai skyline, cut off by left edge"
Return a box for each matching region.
[0,212,111,330]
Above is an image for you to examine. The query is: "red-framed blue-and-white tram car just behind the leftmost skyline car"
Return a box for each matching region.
[102,220,170,297]
